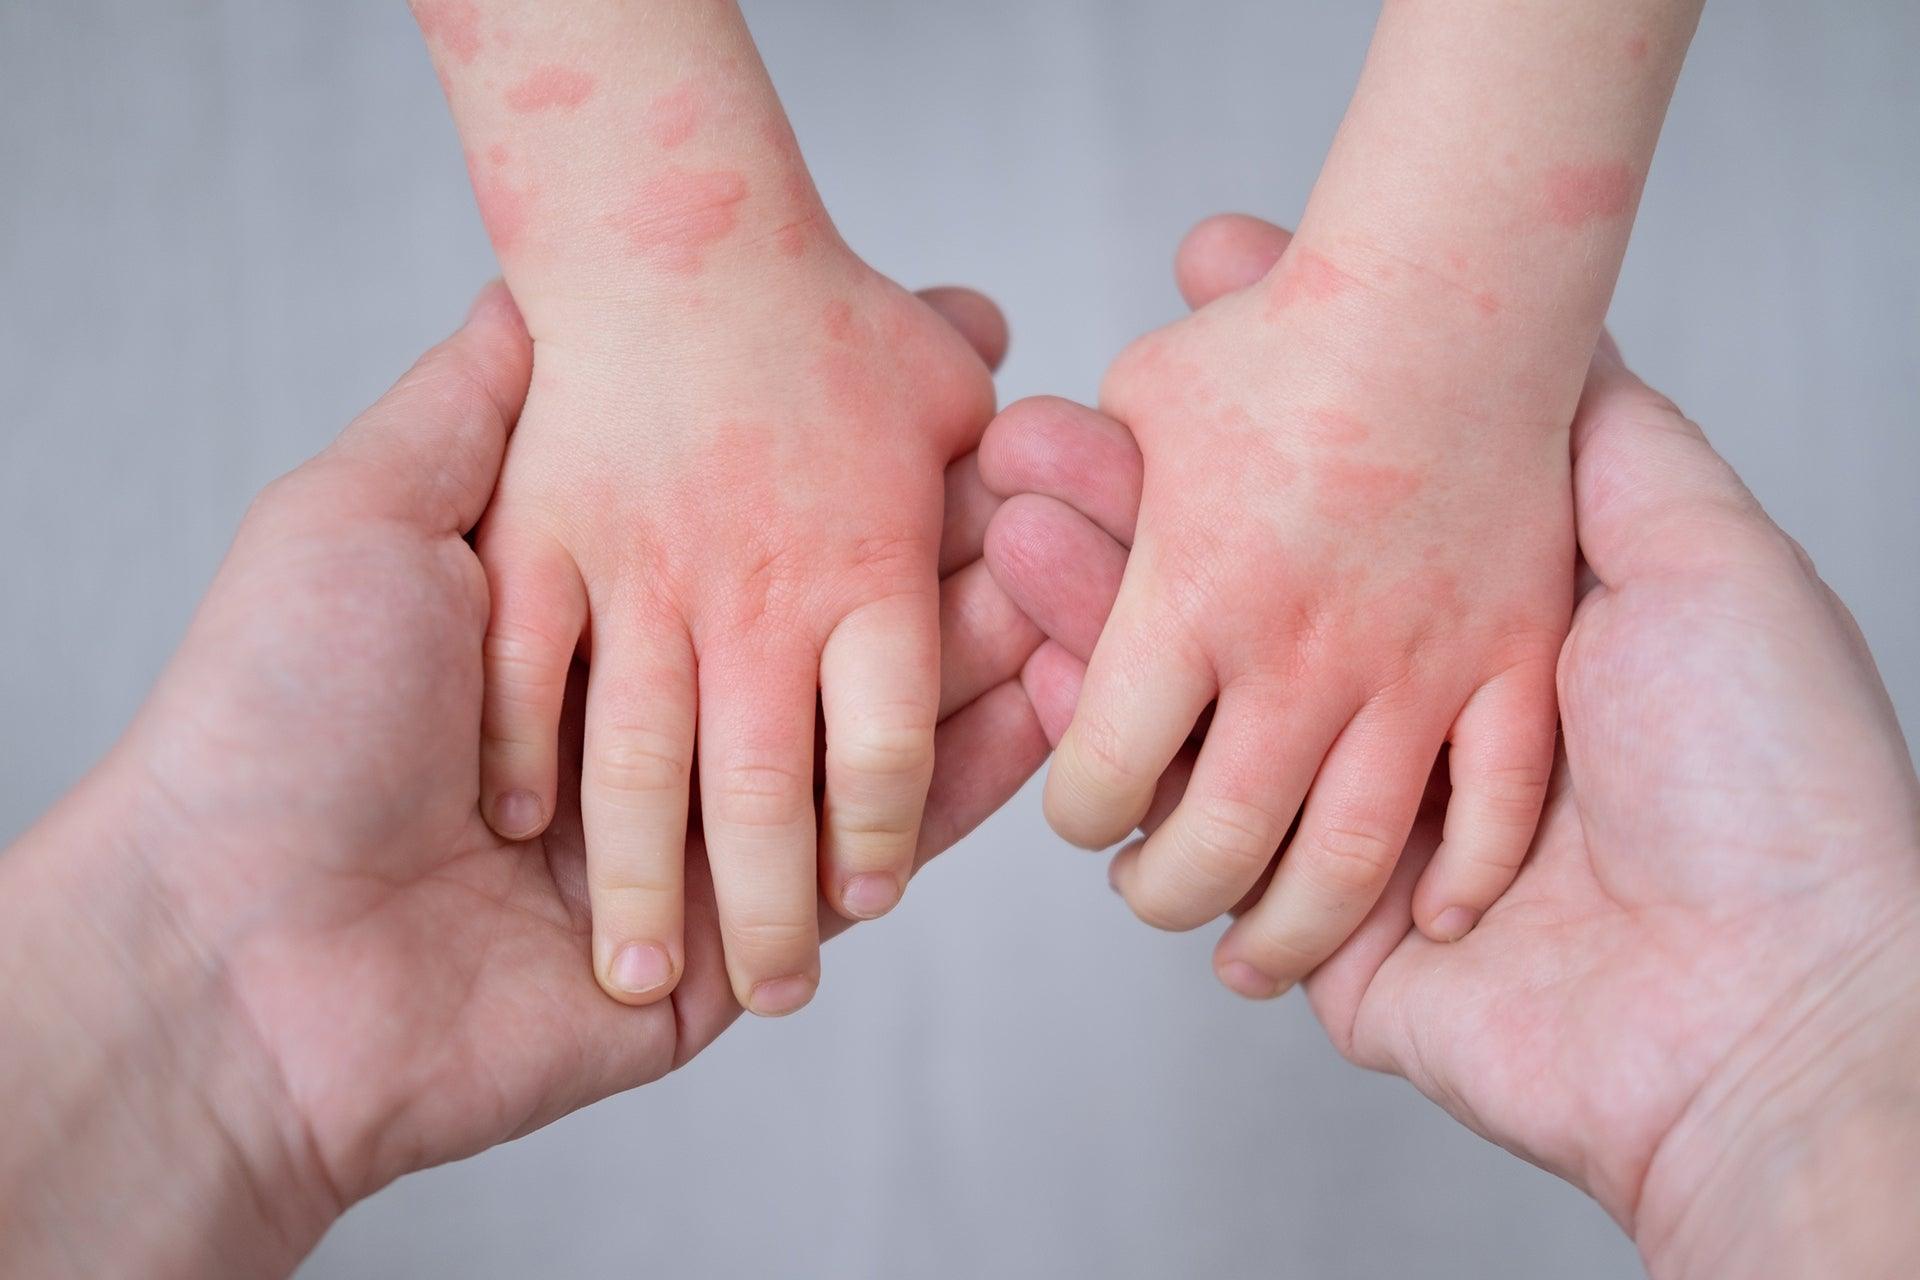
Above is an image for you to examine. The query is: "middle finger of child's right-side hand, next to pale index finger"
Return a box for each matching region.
[1112,683,1340,929]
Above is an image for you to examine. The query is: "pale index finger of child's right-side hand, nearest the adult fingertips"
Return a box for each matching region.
[1044,580,1215,848]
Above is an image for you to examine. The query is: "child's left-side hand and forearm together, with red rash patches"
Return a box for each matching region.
[415,0,995,1015]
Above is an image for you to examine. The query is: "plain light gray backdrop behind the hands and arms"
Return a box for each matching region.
[0,0,1920,1278]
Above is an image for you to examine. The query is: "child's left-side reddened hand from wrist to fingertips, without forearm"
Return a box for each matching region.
[478,247,993,1013]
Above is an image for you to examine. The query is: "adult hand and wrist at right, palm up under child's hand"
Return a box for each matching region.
[981,219,1920,1274]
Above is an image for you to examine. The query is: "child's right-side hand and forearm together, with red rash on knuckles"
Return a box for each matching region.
[1046,0,1699,998]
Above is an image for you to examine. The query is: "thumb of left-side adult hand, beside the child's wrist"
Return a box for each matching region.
[317,282,534,533]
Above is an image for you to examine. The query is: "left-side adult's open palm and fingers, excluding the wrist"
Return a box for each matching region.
[112,288,1046,1221]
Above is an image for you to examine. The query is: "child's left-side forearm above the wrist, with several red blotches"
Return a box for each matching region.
[413,0,826,338]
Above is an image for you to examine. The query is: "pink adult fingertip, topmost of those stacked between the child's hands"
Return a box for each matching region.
[979,395,1142,545]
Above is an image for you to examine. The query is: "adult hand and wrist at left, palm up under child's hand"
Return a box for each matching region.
[0,288,1046,1274]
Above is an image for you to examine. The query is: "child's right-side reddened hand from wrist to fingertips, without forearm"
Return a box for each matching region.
[1013,237,1574,996]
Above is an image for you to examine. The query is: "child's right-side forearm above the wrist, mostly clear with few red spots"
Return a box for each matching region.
[1281,0,1701,413]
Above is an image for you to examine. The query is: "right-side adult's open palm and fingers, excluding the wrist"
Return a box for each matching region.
[981,223,1920,1226]
